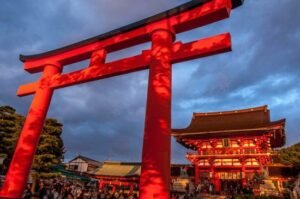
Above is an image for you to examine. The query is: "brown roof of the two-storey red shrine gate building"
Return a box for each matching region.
[172,105,285,147]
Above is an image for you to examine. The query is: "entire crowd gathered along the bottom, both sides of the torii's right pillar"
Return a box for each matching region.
[0,178,292,199]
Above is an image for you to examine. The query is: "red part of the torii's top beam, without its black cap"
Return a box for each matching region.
[24,0,231,73]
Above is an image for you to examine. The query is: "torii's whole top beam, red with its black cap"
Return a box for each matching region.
[20,0,243,73]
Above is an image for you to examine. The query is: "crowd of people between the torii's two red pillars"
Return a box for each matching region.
[23,179,138,199]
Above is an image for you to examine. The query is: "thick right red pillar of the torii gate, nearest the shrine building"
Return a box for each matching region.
[140,29,175,199]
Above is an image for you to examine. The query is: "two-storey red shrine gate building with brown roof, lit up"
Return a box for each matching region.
[172,106,285,192]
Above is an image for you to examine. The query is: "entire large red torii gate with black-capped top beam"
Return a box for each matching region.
[0,0,243,199]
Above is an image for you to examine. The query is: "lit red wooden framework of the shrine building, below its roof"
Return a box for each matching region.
[183,134,271,190]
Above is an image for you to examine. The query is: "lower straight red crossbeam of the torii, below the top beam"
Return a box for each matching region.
[17,33,231,96]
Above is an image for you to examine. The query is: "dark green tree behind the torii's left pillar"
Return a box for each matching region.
[0,106,64,177]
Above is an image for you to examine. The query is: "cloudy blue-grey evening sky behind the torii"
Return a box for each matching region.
[0,0,300,163]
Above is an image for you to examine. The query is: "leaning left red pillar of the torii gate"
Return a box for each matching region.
[0,63,61,198]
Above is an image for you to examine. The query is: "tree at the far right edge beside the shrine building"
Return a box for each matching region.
[279,143,300,166]
